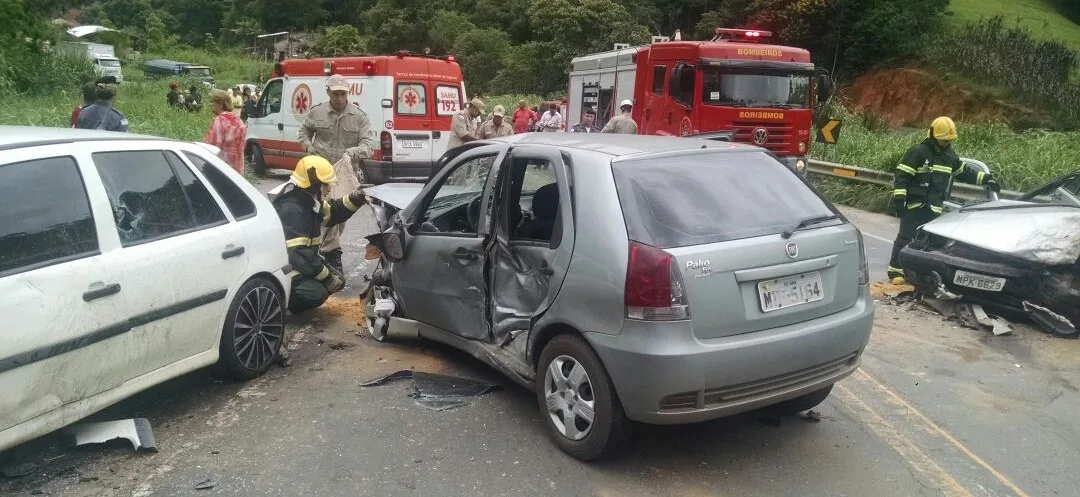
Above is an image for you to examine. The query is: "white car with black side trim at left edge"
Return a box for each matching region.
[0,126,291,451]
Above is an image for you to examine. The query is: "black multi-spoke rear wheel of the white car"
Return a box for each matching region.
[218,278,285,381]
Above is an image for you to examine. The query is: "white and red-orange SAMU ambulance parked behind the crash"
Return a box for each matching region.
[247,52,465,184]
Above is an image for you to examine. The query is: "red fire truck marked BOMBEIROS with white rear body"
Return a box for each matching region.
[567,28,832,171]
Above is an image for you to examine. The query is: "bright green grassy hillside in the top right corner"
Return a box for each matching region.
[949,0,1080,52]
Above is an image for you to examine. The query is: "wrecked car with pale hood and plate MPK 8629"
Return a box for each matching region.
[901,172,1080,338]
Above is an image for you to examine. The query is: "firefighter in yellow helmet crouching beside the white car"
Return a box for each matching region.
[273,156,366,313]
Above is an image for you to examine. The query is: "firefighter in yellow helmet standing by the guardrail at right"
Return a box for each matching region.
[889,117,1001,284]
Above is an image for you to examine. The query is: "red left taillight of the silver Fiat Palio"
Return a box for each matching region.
[624,242,690,321]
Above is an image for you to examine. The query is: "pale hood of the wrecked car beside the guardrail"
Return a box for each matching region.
[922,201,1080,266]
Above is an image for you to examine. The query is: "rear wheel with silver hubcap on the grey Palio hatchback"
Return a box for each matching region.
[536,335,627,461]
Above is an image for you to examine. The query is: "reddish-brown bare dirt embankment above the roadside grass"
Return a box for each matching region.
[843,68,1042,127]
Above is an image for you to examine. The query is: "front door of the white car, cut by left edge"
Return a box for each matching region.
[0,145,132,438]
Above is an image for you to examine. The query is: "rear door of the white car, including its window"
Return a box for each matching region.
[83,142,251,377]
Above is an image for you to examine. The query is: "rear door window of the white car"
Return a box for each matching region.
[93,150,226,246]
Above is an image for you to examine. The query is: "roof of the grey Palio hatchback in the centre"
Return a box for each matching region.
[491,133,765,157]
